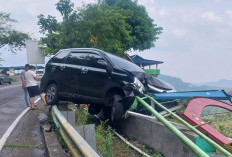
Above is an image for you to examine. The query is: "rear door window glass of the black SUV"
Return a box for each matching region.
[66,52,88,65]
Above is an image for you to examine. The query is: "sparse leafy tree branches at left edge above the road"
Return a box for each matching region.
[0,12,29,52]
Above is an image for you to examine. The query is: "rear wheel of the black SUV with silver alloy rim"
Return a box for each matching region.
[45,83,58,105]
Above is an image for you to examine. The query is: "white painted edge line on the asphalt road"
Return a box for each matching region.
[0,98,40,152]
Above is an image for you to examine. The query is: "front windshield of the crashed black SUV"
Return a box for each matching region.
[106,53,144,72]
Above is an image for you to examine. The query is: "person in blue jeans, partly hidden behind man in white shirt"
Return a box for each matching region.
[21,64,30,107]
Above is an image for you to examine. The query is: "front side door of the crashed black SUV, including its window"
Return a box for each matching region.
[82,52,109,98]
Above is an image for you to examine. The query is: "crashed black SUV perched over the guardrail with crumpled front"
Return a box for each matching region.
[41,48,173,121]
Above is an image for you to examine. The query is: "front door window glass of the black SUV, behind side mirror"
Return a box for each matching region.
[86,53,106,69]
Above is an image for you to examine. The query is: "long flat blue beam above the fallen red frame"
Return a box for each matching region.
[153,90,232,101]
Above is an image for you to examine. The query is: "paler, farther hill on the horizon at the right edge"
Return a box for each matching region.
[195,79,232,88]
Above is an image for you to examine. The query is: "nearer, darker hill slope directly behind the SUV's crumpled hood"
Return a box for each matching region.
[159,75,222,92]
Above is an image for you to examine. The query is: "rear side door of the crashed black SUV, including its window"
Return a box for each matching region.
[65,50,88,96]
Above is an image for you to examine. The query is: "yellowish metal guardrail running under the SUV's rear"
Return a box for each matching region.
[52,106,100,157]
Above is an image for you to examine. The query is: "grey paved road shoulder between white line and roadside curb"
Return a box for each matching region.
[0,101,49,157]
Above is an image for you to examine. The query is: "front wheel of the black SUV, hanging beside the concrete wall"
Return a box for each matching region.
[110,94,124,122]
